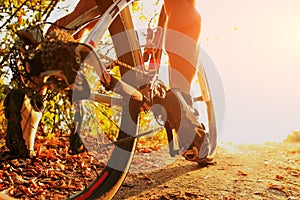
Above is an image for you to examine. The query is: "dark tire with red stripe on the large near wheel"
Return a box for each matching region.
[66,0,140,199]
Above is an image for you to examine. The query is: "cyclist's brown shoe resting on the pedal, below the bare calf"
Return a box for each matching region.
[161,89,209,163]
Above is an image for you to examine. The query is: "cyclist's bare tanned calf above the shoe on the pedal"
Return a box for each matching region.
[164,0,201,93]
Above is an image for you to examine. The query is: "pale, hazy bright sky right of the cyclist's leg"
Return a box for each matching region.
[198,0,300,143]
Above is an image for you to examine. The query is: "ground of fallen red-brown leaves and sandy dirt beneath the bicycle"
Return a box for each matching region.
[0,138,300,200]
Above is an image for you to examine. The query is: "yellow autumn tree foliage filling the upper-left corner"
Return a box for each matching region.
[0,0,58,90]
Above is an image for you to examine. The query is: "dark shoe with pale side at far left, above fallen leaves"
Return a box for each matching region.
[4,89,44,157]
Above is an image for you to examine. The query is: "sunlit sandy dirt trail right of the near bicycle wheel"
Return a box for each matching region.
[114,143,300,200]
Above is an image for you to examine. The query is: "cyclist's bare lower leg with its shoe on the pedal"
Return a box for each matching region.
[165,0,208,163]
